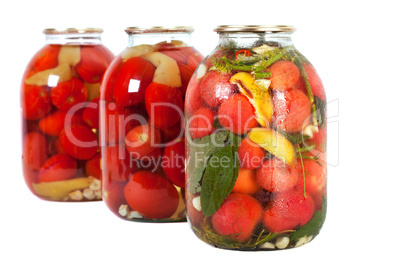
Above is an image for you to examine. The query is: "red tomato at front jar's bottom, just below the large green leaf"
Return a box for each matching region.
[211,193,262,242]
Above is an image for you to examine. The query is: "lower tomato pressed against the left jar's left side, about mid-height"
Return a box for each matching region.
[22,132,48,171]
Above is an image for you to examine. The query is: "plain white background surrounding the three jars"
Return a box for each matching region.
[0,0,402,267]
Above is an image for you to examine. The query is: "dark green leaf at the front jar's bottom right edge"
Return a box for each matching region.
[290,198,327,241]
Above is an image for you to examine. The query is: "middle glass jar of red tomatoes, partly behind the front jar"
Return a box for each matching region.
[100,27,203,222]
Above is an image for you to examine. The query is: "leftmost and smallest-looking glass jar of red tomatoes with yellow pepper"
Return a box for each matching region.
[21,28,114,201]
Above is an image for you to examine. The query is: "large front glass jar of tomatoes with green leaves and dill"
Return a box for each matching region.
[185,26,326,250]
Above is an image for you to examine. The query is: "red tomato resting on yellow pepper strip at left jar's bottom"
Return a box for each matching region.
[39,154,77,182]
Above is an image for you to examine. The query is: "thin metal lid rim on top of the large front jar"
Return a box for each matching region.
[214,25,296,33]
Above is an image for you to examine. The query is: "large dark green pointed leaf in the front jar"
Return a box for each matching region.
[201,145,237,217]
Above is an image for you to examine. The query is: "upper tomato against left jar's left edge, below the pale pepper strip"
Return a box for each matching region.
[21,85,52,120]
